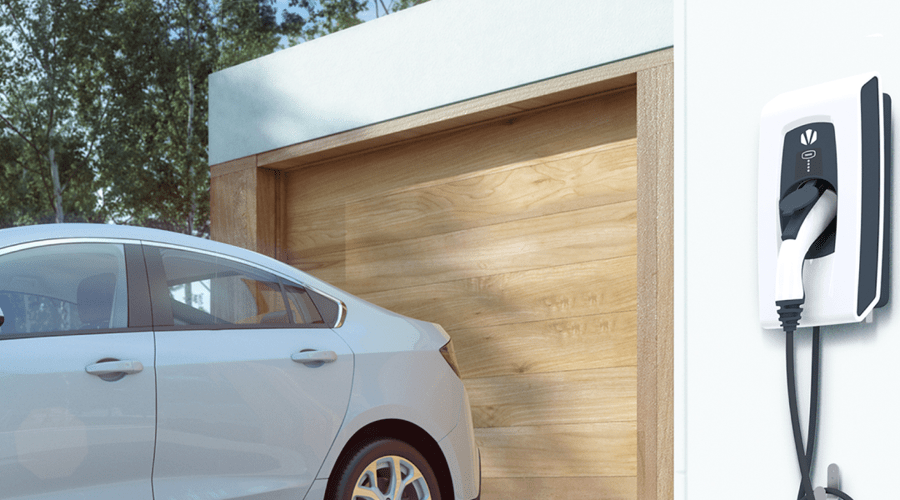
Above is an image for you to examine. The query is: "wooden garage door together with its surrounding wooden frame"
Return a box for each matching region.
[211,2,673,499]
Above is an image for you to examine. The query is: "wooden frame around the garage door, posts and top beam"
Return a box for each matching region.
[210,48,674,500]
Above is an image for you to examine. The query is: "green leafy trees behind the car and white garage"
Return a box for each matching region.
[0,0,426,236]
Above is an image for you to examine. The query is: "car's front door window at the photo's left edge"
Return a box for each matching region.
[0,243,128,336]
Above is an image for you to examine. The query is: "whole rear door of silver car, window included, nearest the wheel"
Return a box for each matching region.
[145,246,353,500]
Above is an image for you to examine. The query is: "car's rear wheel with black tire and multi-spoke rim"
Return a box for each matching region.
[333,439,441,500]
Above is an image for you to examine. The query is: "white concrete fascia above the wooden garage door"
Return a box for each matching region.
[209,0,673,164]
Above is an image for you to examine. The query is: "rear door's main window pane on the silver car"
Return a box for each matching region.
[159,248,291,327]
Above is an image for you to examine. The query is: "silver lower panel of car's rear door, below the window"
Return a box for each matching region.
[153,328,353,500]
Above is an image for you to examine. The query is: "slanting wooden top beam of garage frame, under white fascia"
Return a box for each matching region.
[258,49,672,170]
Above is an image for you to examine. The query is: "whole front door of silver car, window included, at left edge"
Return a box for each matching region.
[0,240,156,500]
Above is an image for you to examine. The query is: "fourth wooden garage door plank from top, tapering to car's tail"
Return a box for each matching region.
[361,256,637,329]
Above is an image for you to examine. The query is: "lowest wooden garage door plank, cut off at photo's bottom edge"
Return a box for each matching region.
[481,476,637,500]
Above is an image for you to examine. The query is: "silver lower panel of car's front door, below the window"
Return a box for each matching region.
[0,332,156,500]
